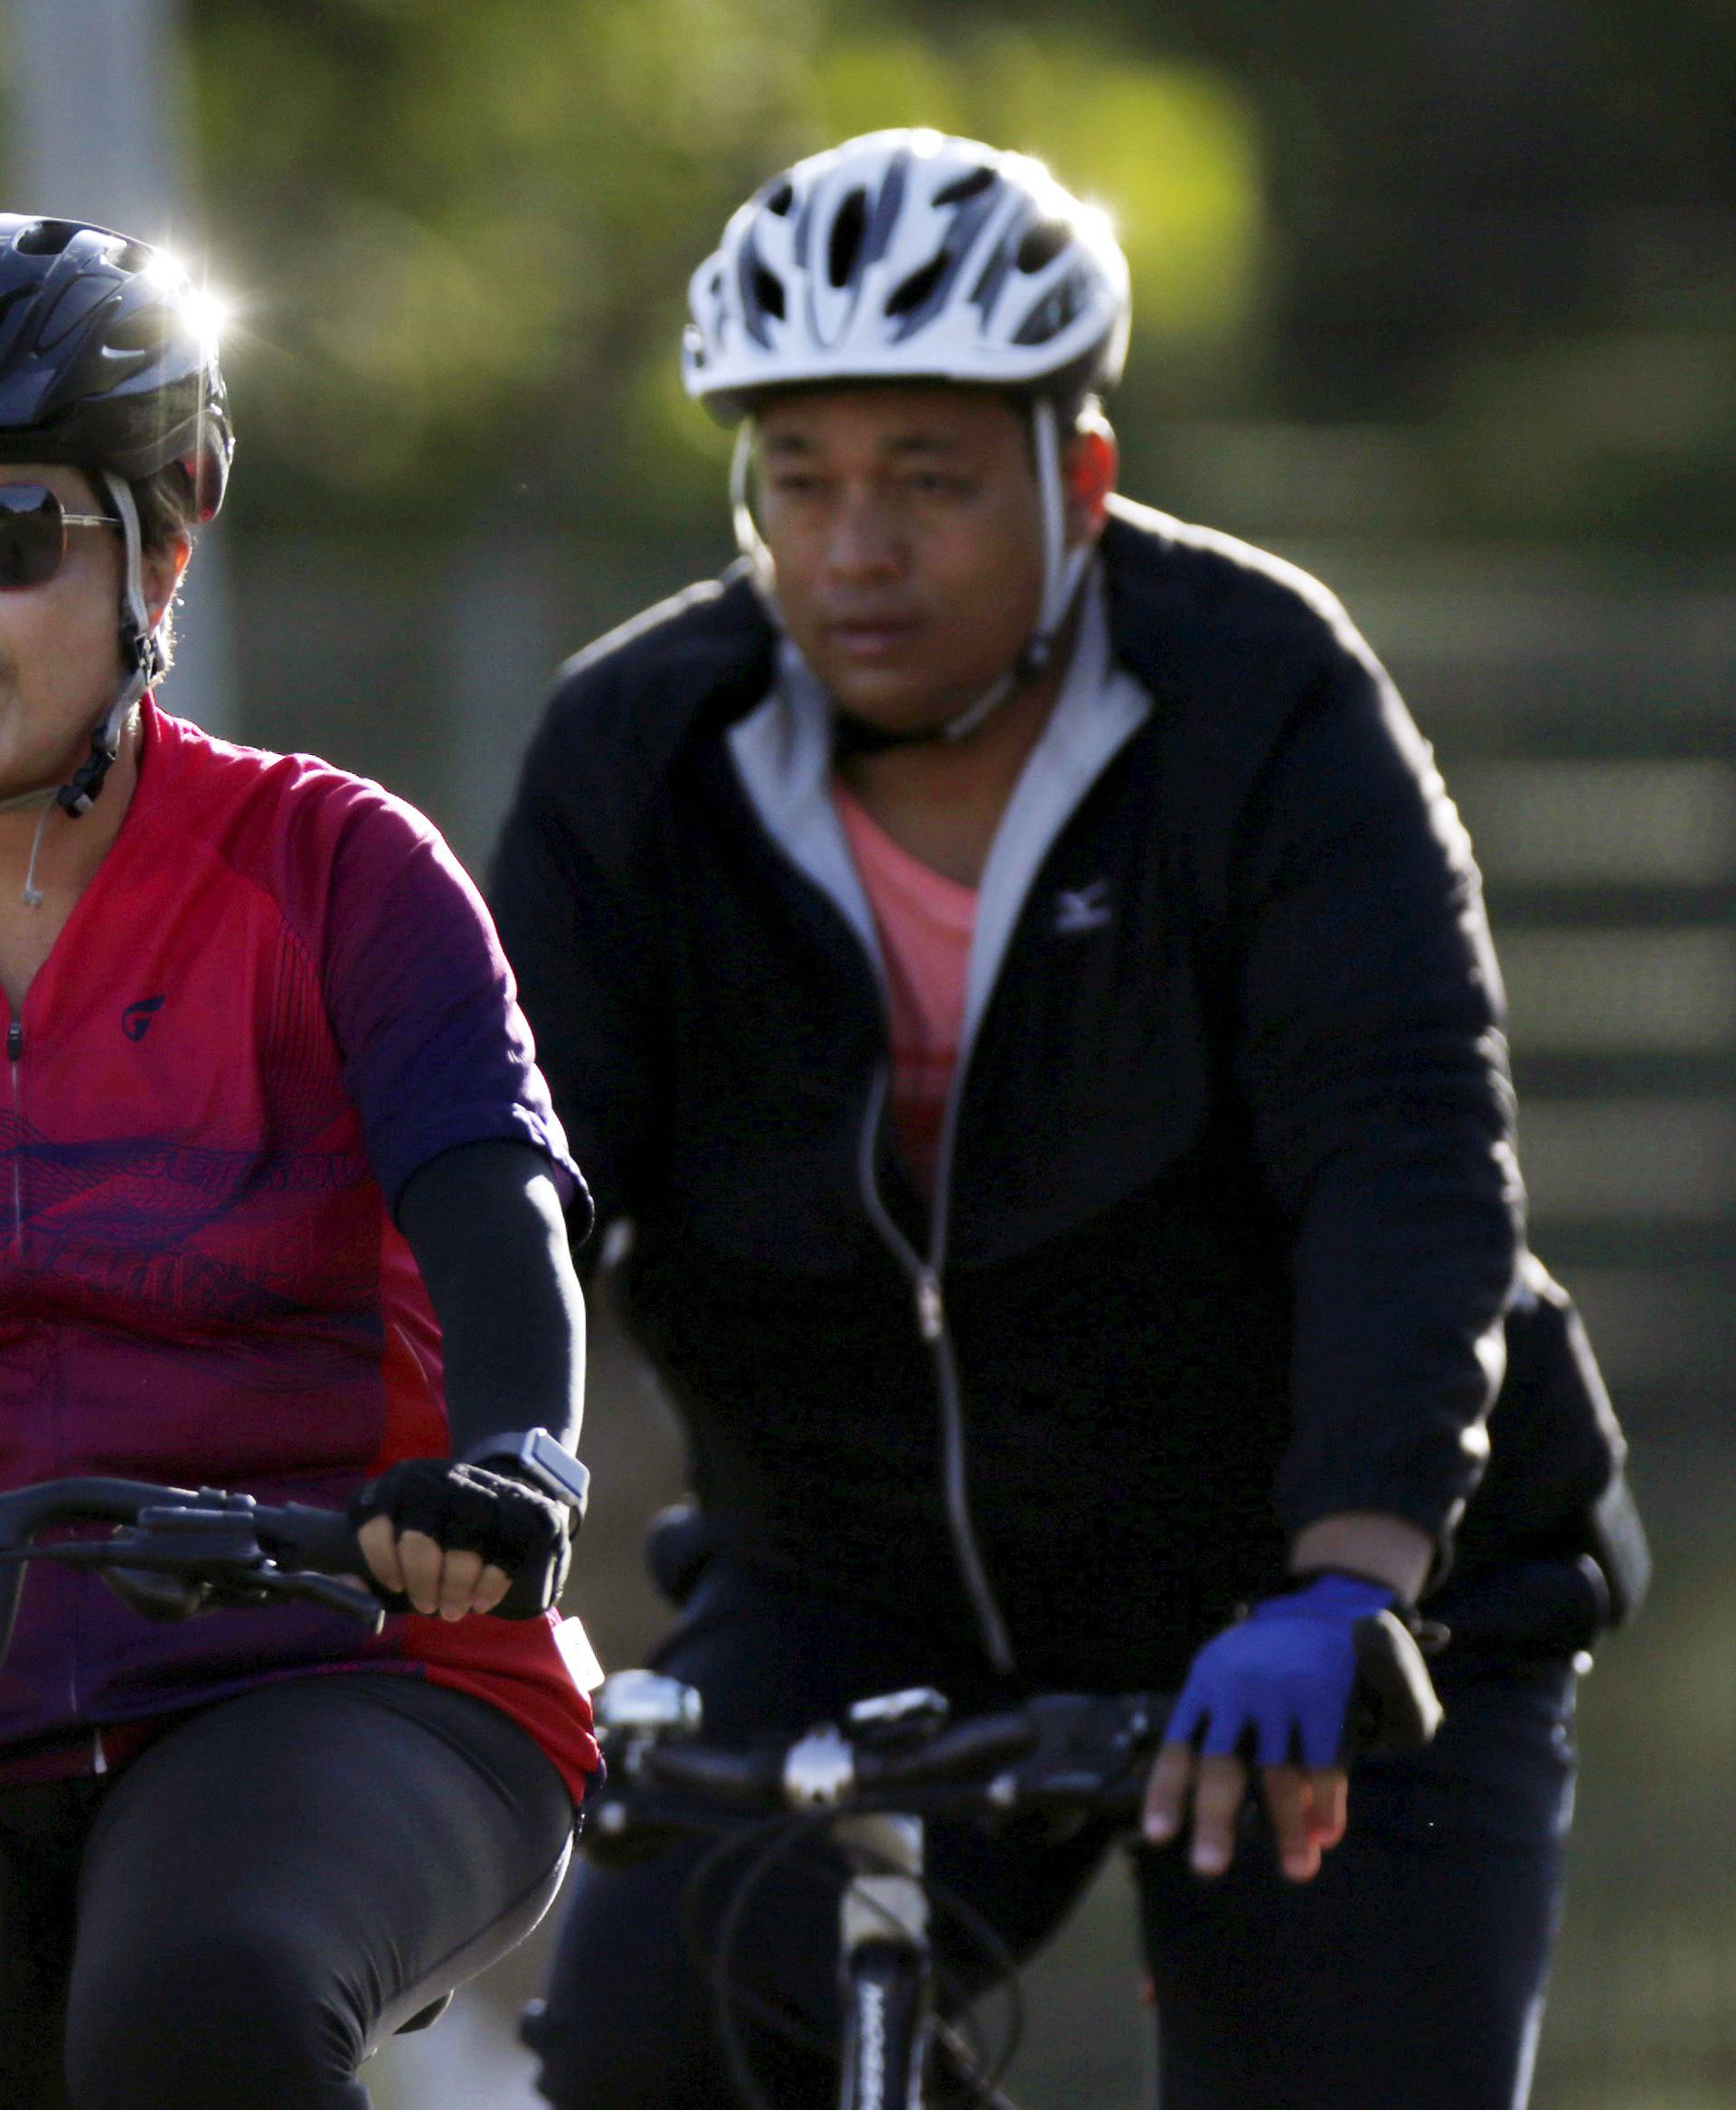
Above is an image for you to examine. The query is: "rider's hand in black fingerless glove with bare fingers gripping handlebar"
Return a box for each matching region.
[350,1458,570,1621]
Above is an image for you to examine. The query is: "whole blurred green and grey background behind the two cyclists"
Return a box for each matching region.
[0,0,1736,2110]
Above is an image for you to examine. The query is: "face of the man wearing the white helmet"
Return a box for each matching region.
[760,386,1042,732]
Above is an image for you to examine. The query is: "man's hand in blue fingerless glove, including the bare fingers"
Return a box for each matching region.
[1143,1574,1399,1882]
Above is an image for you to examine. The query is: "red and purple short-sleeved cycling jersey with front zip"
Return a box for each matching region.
[0,701,597,1794]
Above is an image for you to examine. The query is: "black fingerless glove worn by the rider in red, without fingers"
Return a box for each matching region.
[350,1458,571,1618]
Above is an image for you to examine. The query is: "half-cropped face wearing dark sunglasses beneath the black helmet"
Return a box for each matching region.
[0,462,184,797]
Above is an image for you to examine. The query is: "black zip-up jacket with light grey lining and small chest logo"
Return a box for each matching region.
[494,502,1645,1686]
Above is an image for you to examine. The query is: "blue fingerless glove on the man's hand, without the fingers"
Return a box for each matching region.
[1165,1574,1399,1766]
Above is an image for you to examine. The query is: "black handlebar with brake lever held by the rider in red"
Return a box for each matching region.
[0,1477,551,1663]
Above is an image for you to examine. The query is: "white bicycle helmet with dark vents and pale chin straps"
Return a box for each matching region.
[682,131,1128,745]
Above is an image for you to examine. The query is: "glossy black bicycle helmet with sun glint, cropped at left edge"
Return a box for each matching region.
[0,213,234,521]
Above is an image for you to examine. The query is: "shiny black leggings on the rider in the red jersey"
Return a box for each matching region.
[0,1673,571,2110]
